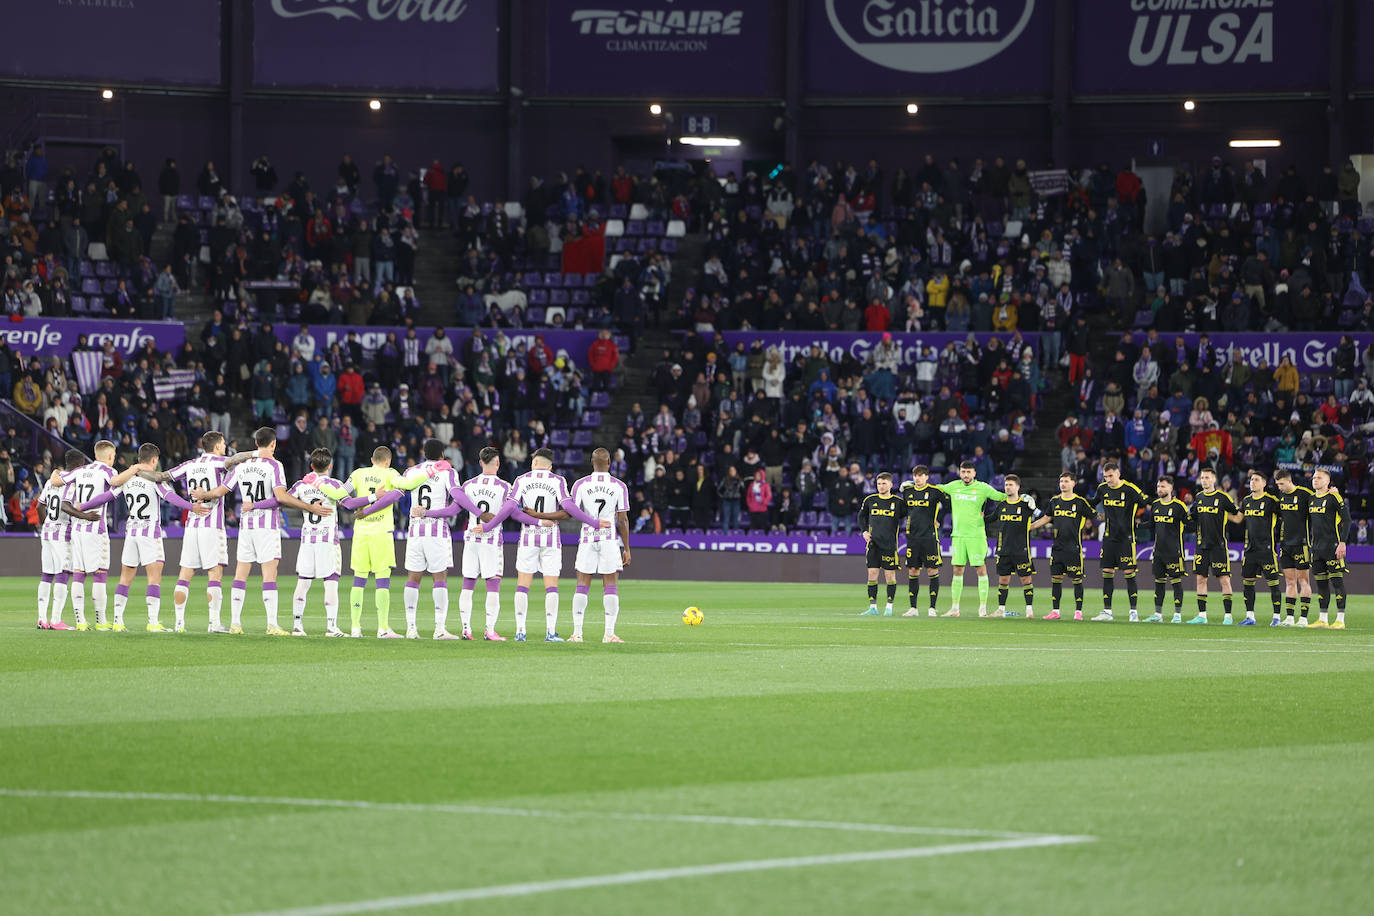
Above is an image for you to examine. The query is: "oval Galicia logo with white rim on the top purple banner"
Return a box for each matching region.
[826,0,1035,73]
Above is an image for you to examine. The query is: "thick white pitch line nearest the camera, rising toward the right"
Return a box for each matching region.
[243,835,1095,916]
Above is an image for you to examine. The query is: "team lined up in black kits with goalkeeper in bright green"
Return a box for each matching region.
[859,461,1351,629]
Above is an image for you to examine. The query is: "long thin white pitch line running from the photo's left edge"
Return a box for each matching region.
[0,788,1041,839]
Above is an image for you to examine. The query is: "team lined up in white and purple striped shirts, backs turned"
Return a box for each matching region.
[38,436,631,643]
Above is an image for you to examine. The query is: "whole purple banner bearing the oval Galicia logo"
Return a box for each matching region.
[805,0,1054,96]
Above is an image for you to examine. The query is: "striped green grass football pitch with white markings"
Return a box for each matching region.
[0,577,1374,916]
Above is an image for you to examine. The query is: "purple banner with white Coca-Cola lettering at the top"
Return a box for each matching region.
[253,0,500,95]
